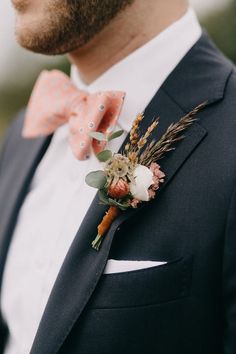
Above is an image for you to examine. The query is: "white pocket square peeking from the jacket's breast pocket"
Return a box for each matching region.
[104,259,167,274]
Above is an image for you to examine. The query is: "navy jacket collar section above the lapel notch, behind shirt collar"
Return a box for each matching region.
[162,32,233,112]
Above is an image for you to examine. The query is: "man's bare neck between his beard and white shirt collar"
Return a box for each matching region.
[69,0,188,84]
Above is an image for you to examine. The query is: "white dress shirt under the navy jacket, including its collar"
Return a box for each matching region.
[1,9,201,354]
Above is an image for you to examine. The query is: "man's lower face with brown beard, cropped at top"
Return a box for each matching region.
[12,0,134,54]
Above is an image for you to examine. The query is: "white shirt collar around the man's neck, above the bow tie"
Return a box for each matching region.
[71,8,202,132]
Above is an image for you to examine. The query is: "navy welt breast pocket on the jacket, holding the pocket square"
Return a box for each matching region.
[89,256,193,309]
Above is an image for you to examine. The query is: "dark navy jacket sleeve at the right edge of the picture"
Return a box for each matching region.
[222,183,236,354]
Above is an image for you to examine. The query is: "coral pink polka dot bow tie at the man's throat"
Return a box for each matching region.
[22,70,125,160]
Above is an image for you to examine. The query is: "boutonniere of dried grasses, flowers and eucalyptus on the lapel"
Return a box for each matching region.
[85,103,206,251]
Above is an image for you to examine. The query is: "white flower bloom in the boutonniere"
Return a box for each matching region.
[130,165,153,202]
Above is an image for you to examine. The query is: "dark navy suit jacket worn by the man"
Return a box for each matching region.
[0,34,236,354]
